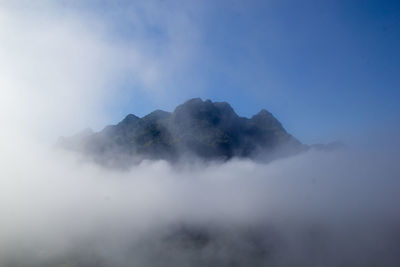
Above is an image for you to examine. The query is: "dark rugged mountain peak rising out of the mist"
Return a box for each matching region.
[59,98,306,166]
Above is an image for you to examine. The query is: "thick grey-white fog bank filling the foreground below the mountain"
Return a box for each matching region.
[0,143,400,266]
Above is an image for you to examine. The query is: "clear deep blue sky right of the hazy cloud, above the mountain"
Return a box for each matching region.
[97,0,400,146]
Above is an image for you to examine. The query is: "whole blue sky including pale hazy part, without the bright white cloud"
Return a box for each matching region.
[0,0,400,143]
